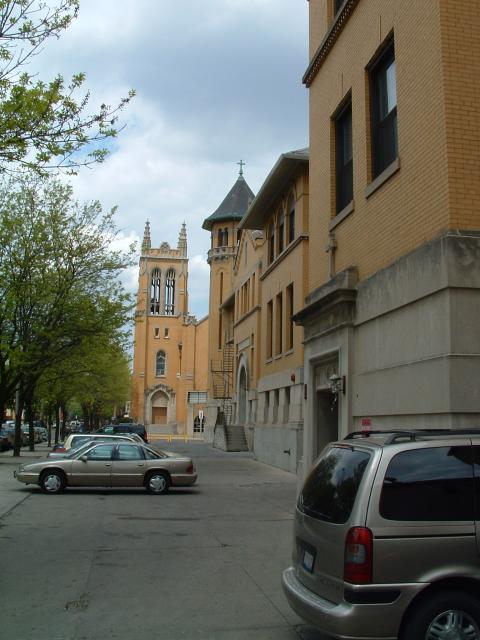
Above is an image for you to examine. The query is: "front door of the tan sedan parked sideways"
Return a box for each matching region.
[69,443,115,487]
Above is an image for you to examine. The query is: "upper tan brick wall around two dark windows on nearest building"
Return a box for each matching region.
[309,0,458,290]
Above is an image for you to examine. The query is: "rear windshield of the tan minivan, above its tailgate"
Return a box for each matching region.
[298,446,370,524]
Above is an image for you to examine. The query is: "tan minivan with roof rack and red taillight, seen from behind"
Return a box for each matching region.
[282,429,480,640]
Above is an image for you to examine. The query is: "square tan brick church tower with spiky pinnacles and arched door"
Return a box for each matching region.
[131,221,208,433]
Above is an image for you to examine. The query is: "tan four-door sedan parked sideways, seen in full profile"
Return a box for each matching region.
[14,441,197,494]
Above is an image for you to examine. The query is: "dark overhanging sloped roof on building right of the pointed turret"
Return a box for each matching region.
[239,147,309,229]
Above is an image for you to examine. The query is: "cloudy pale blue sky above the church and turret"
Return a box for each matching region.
[36,0,308,318]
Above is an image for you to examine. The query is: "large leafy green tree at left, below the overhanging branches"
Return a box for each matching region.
[0,176,133,455]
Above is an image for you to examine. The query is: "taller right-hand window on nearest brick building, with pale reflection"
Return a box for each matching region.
[370,40,398,178]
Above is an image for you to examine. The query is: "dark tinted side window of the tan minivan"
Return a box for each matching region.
[380,447,474,521]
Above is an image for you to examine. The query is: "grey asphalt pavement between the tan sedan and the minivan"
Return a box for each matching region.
[0,442,323,640]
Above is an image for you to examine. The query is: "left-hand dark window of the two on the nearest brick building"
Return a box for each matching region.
[335,100,353,213]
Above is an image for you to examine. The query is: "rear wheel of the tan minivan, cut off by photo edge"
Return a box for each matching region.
[399,590,480,640]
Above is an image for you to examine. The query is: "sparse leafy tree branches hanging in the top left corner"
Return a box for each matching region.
[0,0,134,172]
